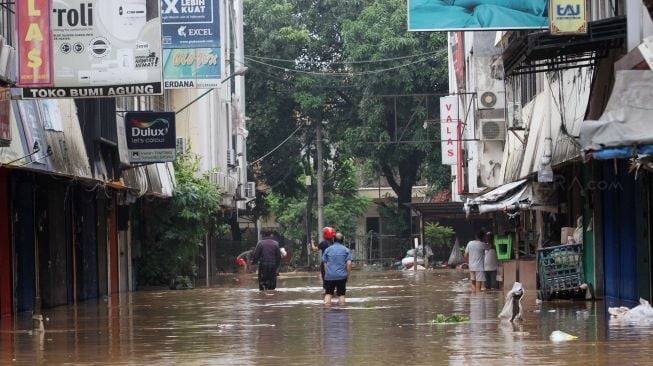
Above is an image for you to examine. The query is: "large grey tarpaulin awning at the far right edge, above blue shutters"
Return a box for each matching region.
[580,70,653,159]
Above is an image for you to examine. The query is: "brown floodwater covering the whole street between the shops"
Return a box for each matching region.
[0,270,653,365]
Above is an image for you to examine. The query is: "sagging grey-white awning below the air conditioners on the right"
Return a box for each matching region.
[464,179,558,216]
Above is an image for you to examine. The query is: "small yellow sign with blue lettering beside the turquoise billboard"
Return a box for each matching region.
[549,0,587,34]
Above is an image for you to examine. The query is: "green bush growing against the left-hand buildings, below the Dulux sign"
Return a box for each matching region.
[137,152,220,285]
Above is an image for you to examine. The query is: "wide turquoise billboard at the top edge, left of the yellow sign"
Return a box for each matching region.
[408,0,549,31]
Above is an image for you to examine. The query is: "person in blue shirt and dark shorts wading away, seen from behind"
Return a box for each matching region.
[322,233,353,305]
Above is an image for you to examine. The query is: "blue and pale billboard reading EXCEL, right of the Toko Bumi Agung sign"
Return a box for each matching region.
[161,0,220,89]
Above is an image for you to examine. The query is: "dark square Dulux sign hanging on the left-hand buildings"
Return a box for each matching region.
[125,112,177,163]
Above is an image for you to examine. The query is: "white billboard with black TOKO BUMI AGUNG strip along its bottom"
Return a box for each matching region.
[21,0,163,98]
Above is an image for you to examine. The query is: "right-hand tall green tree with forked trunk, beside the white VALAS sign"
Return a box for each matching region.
[340,0,448,236]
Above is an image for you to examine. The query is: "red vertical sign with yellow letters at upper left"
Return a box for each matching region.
[16,0,54,87]
